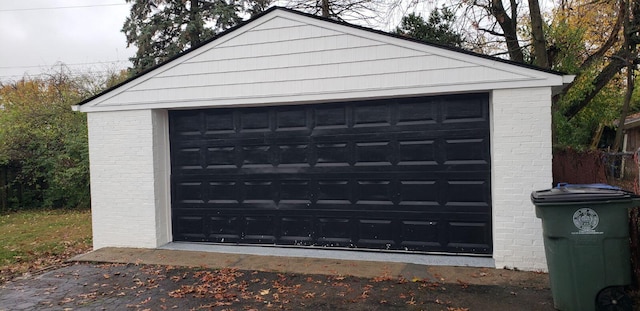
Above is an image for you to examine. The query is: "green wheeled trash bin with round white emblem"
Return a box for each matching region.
[531,184,640,311]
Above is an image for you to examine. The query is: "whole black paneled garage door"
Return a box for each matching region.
[169,94,492,254]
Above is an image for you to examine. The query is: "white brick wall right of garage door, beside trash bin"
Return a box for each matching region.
[491,88,553,270]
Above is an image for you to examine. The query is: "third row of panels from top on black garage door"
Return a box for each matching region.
[173,172,491,210]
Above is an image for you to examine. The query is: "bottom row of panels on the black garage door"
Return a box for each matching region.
[173,212,492,254]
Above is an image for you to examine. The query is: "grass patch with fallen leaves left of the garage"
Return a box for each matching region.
[0,210,91,283]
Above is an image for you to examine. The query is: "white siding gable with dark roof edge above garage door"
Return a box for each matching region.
[75,7,572,112]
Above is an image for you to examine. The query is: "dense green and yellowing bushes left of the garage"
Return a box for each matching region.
[0,71,126,211]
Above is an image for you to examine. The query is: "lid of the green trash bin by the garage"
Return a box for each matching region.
[531,184,640,204]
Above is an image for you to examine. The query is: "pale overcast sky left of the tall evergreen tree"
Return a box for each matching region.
[0,0,135,81]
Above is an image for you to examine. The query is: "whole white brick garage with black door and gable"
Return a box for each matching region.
[75,7,573,270]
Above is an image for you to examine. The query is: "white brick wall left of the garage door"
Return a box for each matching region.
[87,110,170,249]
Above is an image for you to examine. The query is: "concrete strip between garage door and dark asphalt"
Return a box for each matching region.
[70,243,540,285]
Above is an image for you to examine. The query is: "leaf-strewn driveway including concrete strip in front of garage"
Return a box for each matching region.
[0,249,554,311]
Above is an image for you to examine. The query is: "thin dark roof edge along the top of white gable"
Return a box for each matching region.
[77,6,566,106]
